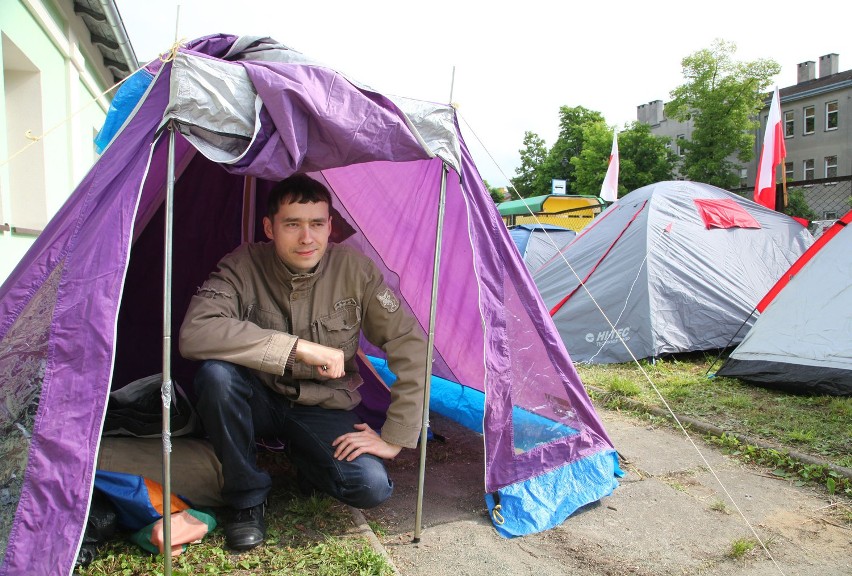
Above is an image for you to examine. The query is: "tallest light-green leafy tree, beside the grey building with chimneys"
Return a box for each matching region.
[665,40,781,189]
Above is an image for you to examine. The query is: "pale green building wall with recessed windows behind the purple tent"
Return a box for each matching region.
[0,0,138,282]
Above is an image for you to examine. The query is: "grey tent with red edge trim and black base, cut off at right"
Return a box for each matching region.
[718,211,852,396]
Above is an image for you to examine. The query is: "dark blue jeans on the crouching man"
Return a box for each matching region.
[195,360,393,509]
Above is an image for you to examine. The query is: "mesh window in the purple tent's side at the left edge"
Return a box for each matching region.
[0,265,62,556]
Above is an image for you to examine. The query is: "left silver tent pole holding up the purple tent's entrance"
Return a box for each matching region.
[161,123,175,576]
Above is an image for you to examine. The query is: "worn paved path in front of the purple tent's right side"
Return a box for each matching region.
[364,411,852,576]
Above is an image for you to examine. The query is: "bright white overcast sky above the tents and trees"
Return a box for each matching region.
[116,0,852,186]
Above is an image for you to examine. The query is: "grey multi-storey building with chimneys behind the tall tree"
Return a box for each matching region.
[637,54,852,220]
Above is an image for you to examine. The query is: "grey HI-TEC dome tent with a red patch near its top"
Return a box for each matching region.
[533,181,813,364]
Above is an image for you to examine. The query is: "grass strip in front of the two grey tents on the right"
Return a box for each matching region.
[577,354,852,497]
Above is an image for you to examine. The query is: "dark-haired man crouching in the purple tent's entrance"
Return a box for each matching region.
[180,174,426,550]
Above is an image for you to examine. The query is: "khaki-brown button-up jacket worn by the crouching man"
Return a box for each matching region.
[180,242,426,448]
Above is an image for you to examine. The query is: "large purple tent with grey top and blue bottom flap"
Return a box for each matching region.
[0,35,620,574]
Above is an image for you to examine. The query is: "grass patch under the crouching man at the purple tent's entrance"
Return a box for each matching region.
[75,454,393,576]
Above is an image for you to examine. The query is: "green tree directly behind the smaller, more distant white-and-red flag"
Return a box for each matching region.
[571,122,677,197]
